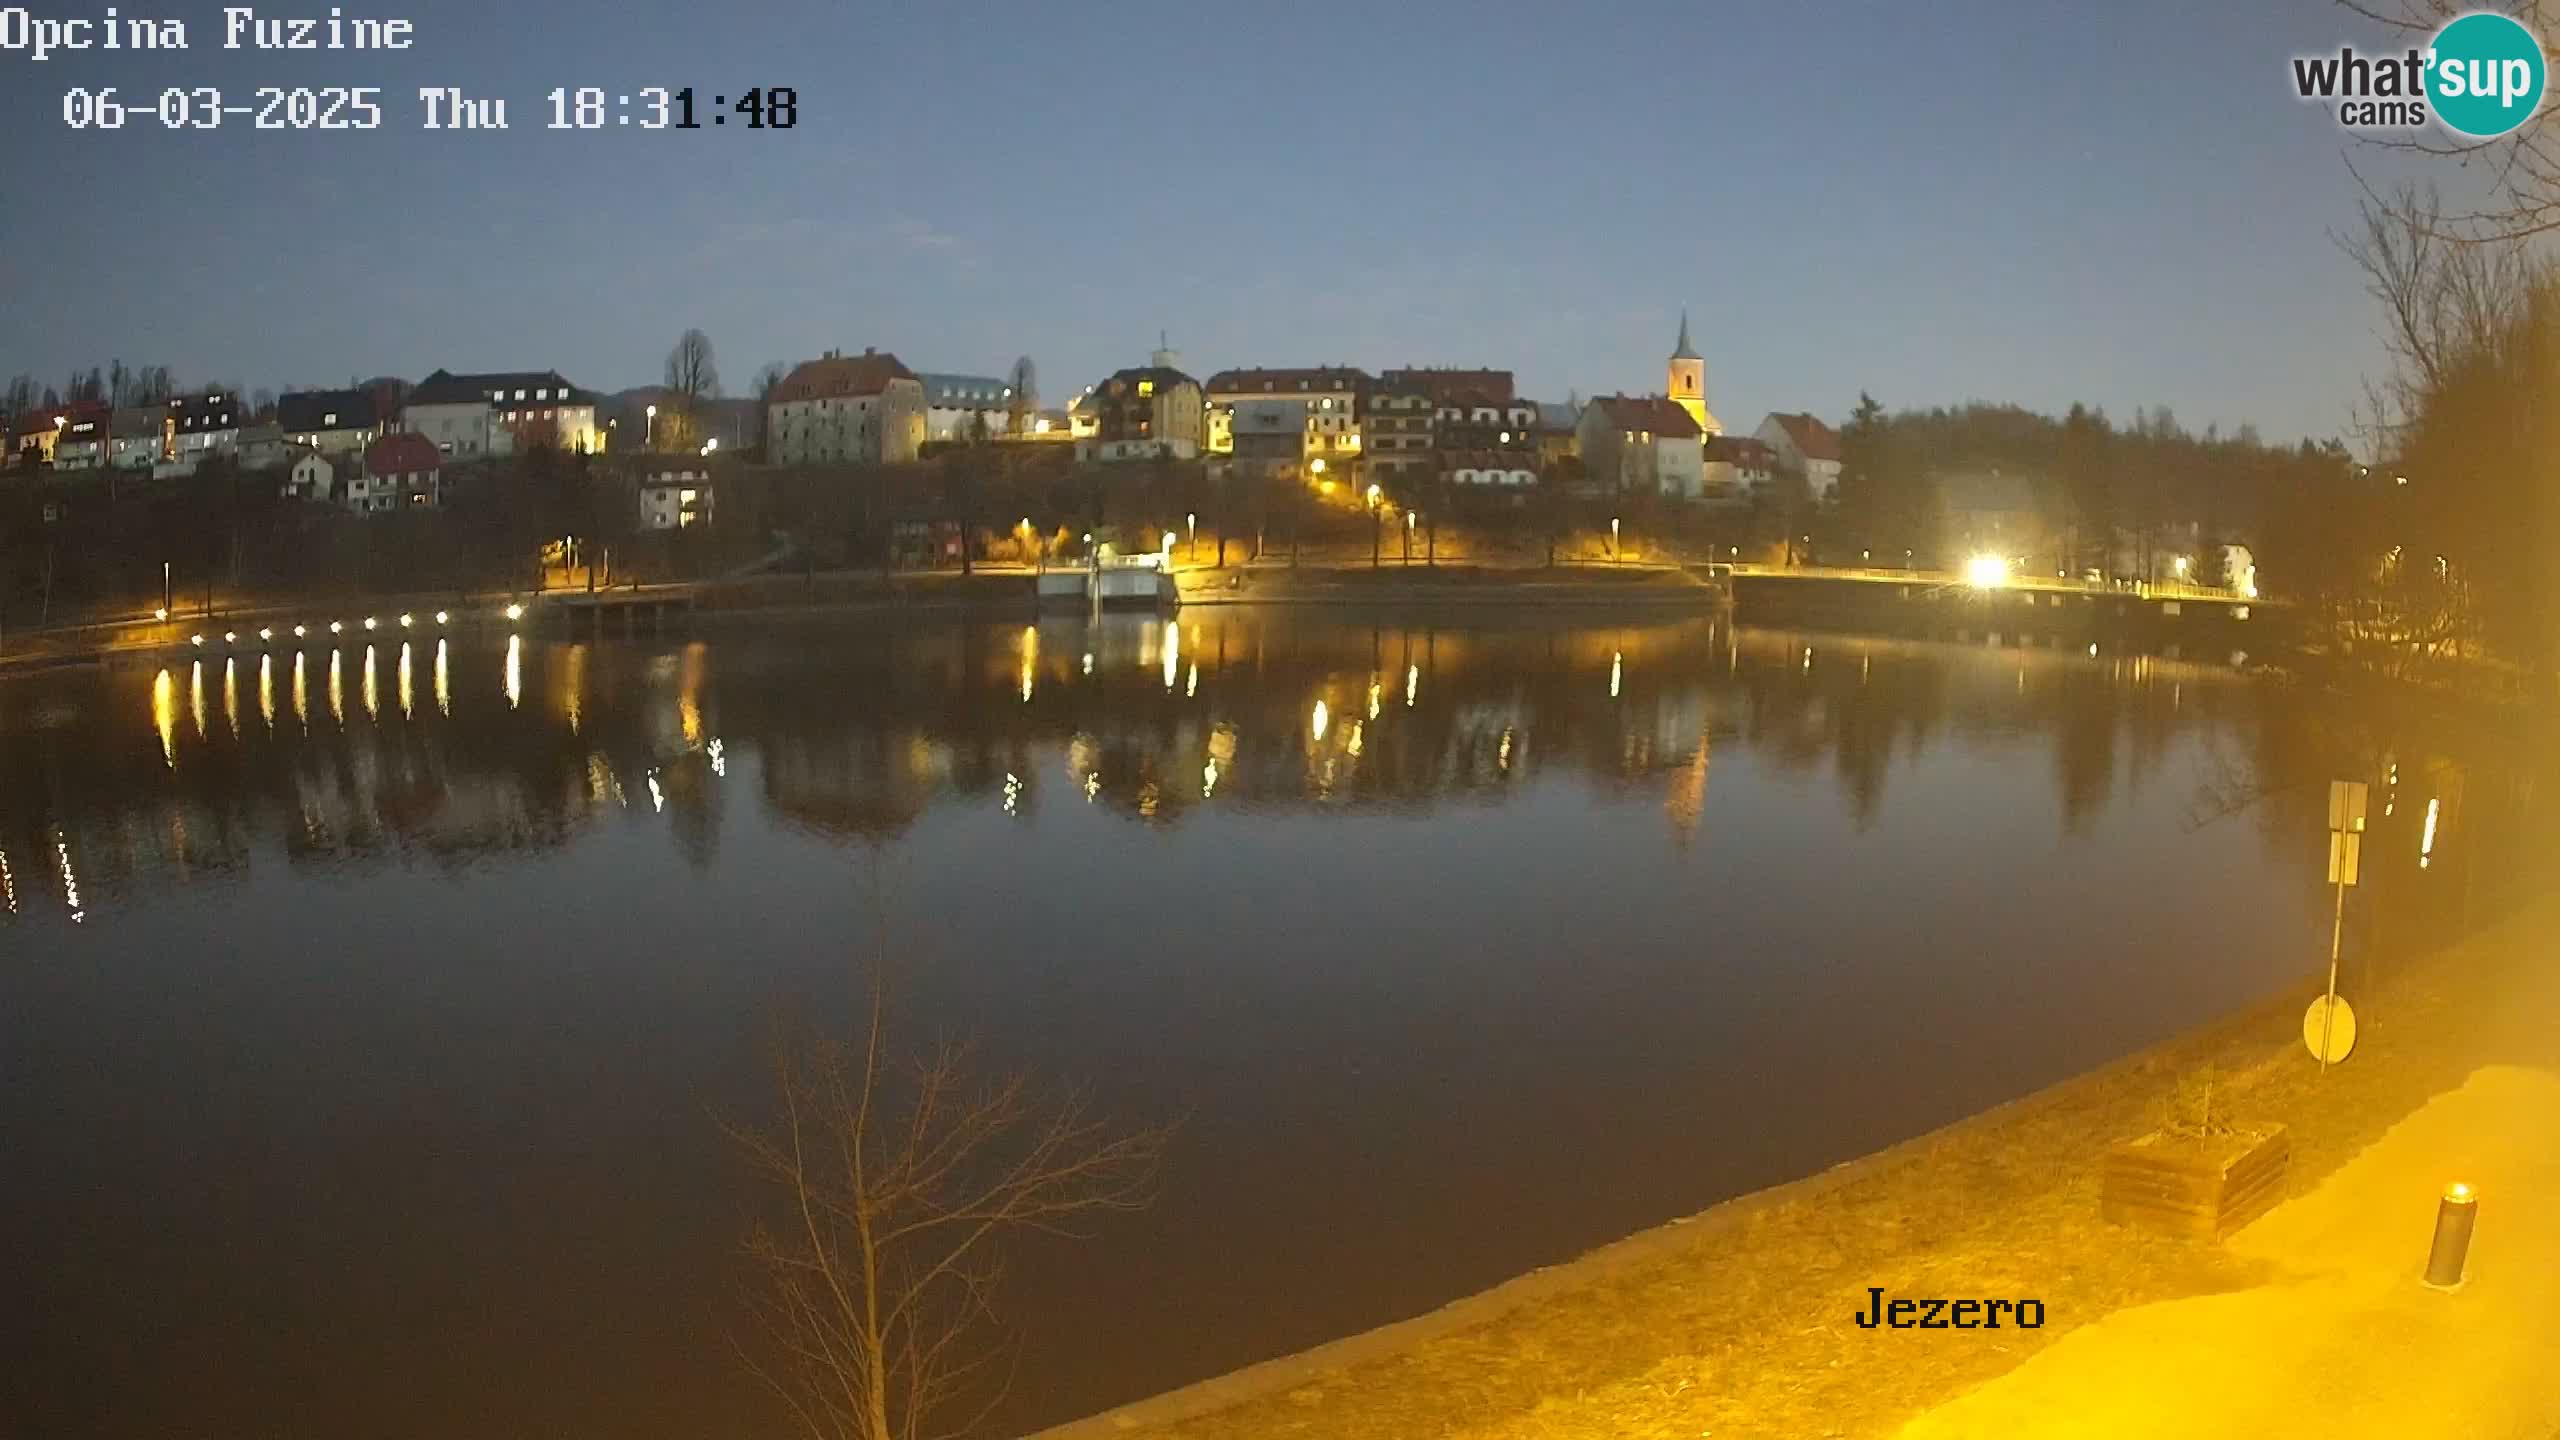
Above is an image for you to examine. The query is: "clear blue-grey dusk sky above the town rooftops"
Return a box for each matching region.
[0,0,2455,441]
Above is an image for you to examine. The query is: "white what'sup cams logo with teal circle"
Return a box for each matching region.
[2294,10,2542,141]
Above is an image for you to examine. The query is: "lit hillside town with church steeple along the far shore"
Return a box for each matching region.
[0,313,2293,605]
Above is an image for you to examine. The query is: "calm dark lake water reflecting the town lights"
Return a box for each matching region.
[0,610,2460,1440]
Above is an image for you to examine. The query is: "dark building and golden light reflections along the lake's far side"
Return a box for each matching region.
[0,612,2455,912]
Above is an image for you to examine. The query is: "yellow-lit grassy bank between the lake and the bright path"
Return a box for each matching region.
[1032,881,2560,1440]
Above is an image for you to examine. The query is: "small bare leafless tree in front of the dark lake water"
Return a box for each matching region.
[730,969,1165,1440]
